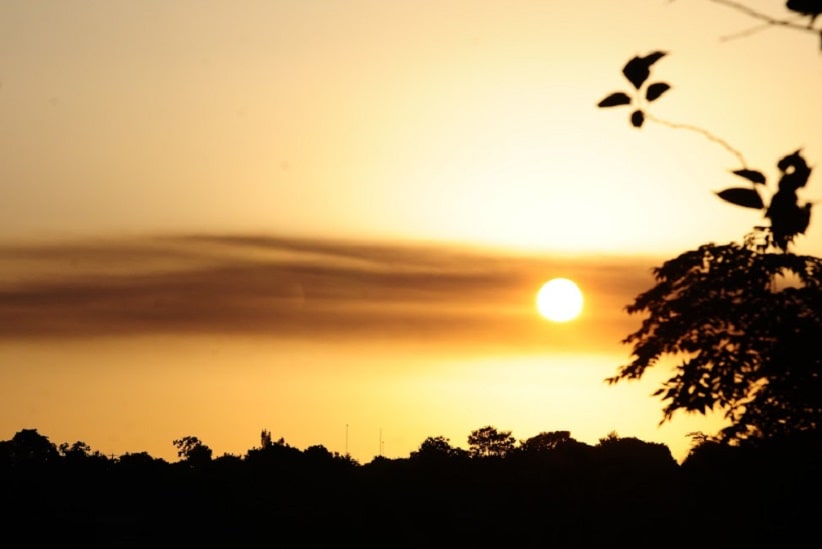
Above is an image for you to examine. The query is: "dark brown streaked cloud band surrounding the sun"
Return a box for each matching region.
[0,236,650,348]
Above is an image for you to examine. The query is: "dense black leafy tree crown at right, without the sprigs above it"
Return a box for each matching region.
[608,244,822,440]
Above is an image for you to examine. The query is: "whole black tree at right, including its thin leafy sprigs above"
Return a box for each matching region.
[598,6,822,442]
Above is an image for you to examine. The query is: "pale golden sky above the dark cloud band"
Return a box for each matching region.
[0,0,822,254]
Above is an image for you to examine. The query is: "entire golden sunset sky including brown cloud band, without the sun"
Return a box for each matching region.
[0,0,822,461]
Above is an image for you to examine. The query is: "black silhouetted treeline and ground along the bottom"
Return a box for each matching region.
[0,430,822,547]
